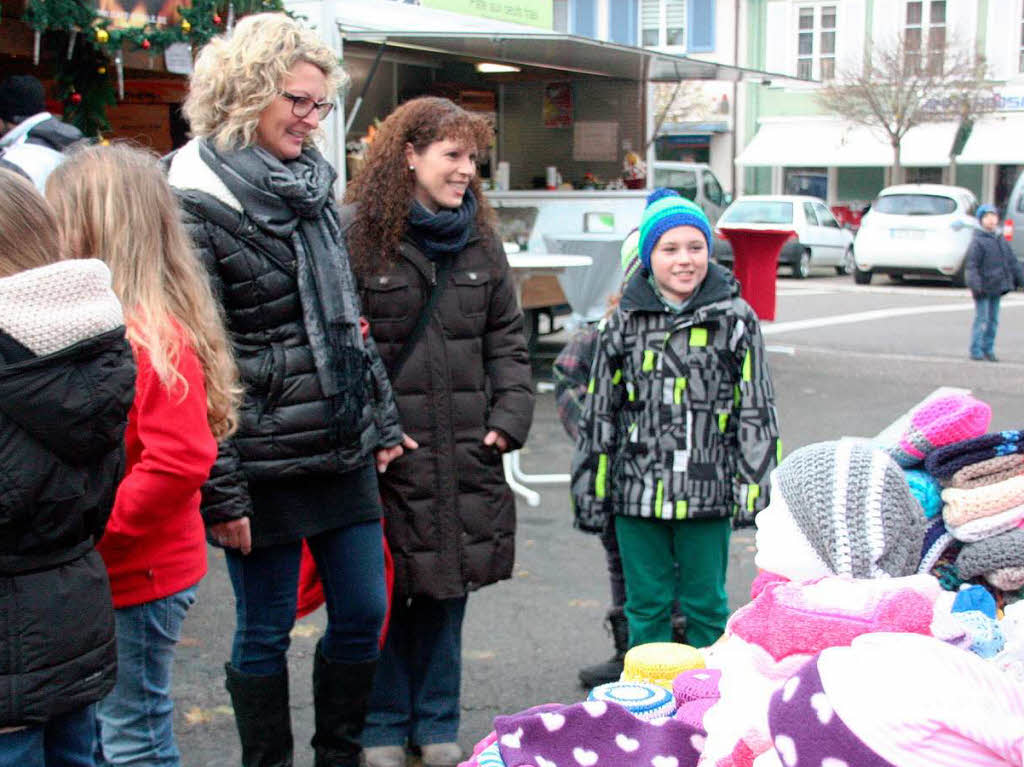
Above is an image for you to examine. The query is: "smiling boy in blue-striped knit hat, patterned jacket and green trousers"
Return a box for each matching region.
[572,189,779,647]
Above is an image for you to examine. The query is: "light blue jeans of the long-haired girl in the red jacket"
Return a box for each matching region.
[96,586,196,767]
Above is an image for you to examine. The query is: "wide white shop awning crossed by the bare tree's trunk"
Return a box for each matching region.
[736,118,956,168]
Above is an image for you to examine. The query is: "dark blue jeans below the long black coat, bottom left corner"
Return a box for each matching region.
[0,705,96,767]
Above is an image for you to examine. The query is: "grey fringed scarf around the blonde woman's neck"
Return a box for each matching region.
[200,140,368,443]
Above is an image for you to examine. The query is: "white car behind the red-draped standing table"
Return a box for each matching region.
[718,195,854,279]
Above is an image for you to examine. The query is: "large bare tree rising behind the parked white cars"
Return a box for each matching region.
[818,35,994,183]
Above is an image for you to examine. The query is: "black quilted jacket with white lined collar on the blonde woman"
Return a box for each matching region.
[169,141,401,525]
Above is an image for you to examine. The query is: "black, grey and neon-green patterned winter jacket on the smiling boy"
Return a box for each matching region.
[572,263,781,530]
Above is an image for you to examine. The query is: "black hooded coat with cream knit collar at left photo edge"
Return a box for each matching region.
[0,328,135,727]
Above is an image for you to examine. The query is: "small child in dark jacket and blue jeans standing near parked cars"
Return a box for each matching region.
[965,205,1024,363]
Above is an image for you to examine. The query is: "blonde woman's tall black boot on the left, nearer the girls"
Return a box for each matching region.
[224,664,293,767]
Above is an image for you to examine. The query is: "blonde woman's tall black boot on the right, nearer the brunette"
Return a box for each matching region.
[312,642,377,767]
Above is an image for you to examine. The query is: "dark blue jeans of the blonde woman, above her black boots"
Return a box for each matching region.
[224,520,387,675]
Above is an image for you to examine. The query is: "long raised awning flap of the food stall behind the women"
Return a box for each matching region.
[338,28,790,82]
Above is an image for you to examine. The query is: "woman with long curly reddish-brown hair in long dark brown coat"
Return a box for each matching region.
[345,97,534,767]
